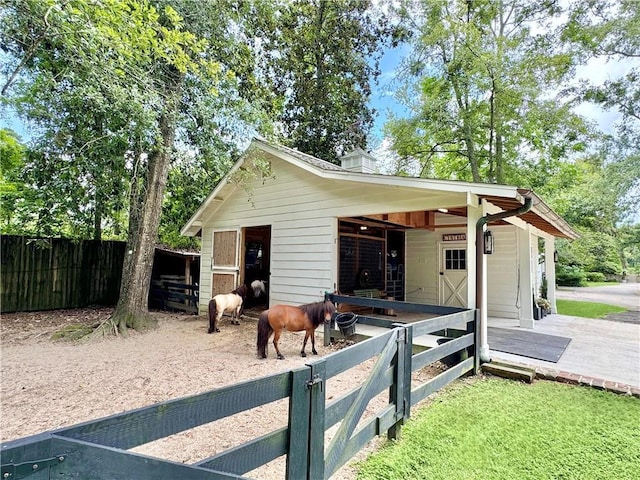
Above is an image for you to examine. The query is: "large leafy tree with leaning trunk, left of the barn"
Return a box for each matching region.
[2,0,272,333]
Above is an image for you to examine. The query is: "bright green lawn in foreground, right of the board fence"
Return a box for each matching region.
[357,377,640,480]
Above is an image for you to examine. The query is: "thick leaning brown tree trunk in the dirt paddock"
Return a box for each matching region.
[109,70,182,334]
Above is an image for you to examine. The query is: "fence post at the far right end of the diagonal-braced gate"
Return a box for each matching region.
[387,323,413,440]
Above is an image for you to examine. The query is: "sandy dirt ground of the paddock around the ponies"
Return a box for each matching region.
[0,308,444,480]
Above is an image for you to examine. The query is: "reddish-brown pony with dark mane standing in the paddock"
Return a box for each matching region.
[256,300,336,360]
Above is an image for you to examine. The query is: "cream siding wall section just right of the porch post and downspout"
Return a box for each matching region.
[487,225,520,318]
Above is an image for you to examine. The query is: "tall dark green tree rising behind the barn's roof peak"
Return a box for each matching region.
[266,0,393,163]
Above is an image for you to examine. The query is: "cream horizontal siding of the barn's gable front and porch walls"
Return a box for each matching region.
[200,157,528,315]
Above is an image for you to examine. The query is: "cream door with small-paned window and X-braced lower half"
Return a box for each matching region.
[438,243,467,308]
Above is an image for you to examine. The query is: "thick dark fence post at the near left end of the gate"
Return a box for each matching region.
[285,366,312,480]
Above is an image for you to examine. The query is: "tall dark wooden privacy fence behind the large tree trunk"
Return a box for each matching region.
[0,235,125,312]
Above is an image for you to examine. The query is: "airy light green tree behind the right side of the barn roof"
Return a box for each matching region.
[387,0,587,186]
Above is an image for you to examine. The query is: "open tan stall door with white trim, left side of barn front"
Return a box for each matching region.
[211,230,240,298]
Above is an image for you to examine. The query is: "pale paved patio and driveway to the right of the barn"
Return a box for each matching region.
[489,283,640,389]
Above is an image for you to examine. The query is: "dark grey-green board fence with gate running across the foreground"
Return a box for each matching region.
[0,296,479,480]
